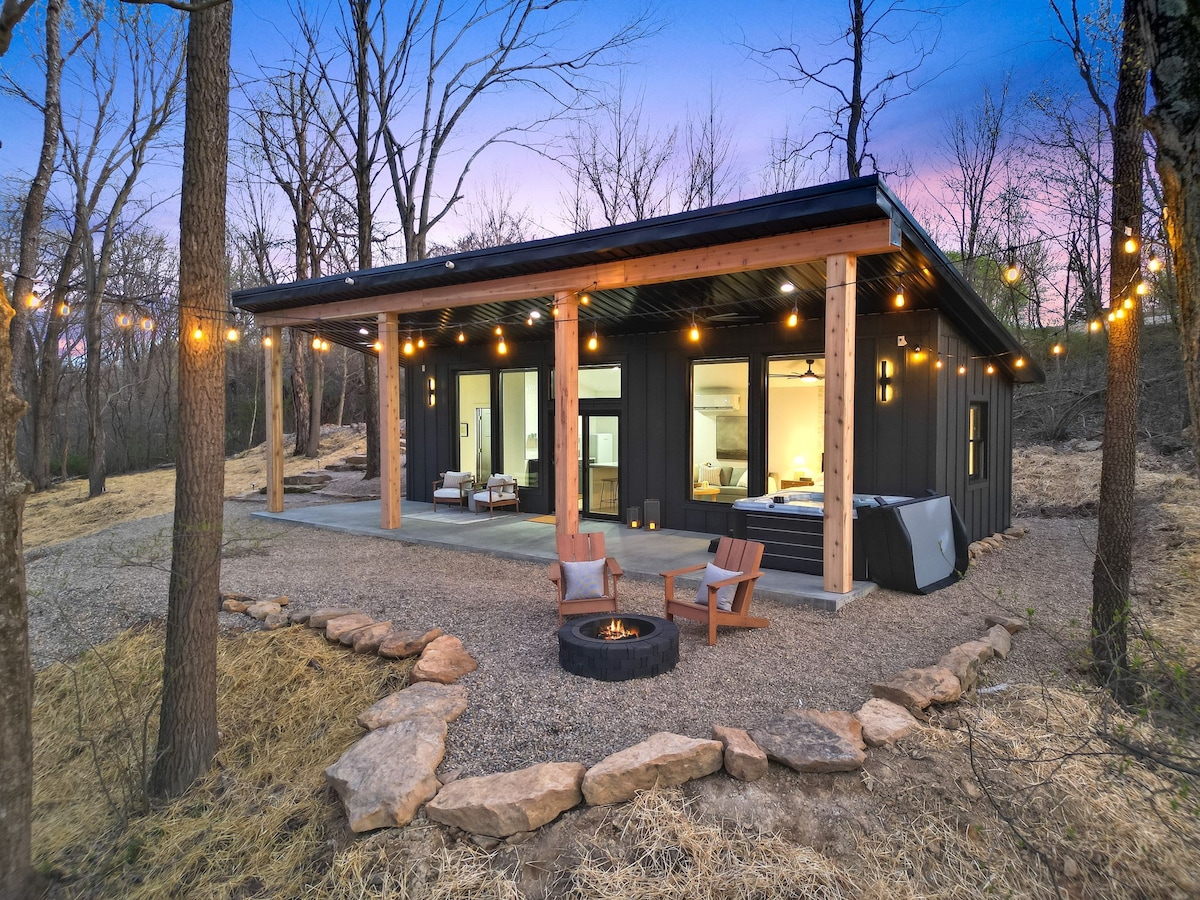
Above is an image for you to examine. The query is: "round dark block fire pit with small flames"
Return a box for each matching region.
[558,612,679,682]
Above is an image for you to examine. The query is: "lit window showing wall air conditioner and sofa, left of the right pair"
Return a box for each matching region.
[690,360,750,503]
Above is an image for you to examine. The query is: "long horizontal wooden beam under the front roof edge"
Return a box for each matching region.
[262,218,900,328]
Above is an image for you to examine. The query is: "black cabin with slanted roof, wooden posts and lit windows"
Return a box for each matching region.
[234,175,1043,600]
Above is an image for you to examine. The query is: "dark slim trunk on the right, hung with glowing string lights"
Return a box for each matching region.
[1092,0,1146,697]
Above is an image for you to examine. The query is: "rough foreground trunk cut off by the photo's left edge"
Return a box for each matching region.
[0,283,35,900]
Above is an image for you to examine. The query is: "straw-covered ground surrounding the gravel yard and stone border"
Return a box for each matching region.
[18,430,1200,898]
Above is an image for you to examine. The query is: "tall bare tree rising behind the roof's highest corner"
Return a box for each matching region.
[754,0,941,178]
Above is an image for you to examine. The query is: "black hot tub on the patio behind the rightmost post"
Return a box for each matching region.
[731,491,911,581]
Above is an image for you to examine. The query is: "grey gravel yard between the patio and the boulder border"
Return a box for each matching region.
[28,488,1094,775]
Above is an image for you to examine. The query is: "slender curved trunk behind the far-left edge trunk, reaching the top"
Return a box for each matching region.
[10,0,62,398]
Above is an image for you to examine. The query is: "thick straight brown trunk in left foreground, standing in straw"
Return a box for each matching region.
[150,2,233,798]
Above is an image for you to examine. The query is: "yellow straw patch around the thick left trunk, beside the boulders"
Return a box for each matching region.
[34,629,408,900]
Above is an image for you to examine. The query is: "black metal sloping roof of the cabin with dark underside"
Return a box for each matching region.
[233,175,1043,382]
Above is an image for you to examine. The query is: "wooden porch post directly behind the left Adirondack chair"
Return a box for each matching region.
[554,293,580,536]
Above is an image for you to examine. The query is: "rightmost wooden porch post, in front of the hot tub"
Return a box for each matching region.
[824,253,858,594]
